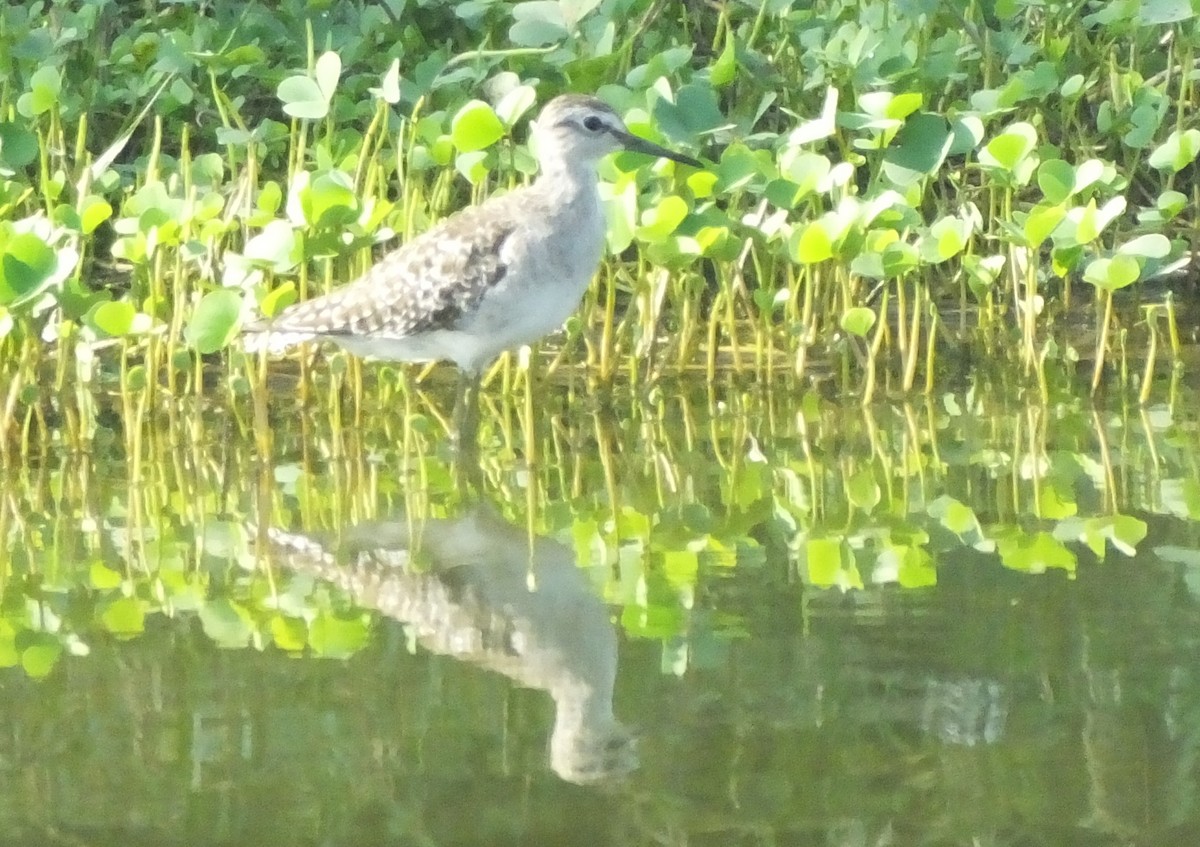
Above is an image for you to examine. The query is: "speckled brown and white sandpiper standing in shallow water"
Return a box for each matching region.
[246,94,702,445]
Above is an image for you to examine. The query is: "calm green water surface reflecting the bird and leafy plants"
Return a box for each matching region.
[0,383,1200,847]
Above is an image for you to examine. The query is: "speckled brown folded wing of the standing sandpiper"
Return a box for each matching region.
[268,198,517,340]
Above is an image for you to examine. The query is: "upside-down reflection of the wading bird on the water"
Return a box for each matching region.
[256,506,637,785]
